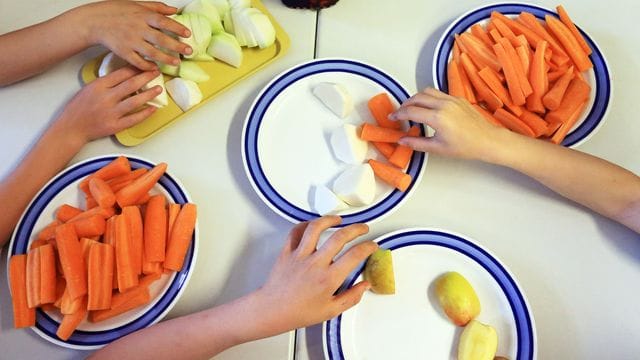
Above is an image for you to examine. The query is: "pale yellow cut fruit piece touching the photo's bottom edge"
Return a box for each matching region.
[458,320,498,360]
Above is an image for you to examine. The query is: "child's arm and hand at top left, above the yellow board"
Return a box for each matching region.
[0,1,191,86]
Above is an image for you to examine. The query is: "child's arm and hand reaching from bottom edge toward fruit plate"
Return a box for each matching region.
[92,216,377,359]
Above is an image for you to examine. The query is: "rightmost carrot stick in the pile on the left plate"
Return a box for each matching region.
[163,203,196,271]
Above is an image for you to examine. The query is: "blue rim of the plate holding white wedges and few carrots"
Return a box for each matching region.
[242,59,427,227]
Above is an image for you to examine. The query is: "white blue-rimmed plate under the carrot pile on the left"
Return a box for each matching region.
[8,155,198,350]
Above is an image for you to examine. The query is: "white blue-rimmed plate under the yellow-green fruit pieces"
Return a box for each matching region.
[323,229,536,360]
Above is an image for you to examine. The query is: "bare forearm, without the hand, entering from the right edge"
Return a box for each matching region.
[484,131,640,232]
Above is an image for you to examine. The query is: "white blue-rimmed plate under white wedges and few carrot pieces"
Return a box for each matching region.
[242,59,427,226]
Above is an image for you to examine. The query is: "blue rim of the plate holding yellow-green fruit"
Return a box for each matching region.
[323,229,536,360]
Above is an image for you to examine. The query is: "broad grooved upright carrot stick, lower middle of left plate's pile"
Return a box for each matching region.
[87,243,114,310]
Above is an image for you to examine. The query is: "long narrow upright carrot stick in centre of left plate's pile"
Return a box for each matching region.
[115,215,138,292]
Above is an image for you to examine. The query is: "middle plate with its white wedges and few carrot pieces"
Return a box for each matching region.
[242,59,427,226]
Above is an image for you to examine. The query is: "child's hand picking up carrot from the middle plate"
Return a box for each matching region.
[390,88,508,159]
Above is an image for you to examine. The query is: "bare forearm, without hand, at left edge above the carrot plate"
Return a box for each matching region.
[0,124,84,247]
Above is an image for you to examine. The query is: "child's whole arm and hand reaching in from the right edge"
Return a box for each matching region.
[393,89,640,232]
